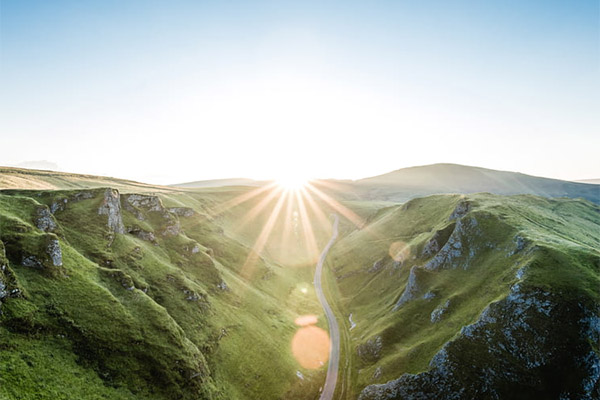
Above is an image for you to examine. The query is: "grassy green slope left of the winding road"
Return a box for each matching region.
[0,189,322,398]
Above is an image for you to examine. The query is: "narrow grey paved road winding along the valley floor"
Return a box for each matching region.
[315,214,340,400]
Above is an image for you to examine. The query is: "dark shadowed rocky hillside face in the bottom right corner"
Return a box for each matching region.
[359,285,600,400]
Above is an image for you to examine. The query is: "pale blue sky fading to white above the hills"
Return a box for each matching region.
[0,0,600,183]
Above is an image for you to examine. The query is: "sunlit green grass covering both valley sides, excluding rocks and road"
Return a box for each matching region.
[0,171,600,399]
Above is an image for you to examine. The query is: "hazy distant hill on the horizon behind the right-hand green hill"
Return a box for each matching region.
[353,164,600,203]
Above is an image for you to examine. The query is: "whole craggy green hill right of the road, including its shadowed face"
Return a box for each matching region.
[330,194,600,399]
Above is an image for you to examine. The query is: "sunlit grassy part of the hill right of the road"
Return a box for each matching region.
[329,194,600,398]
